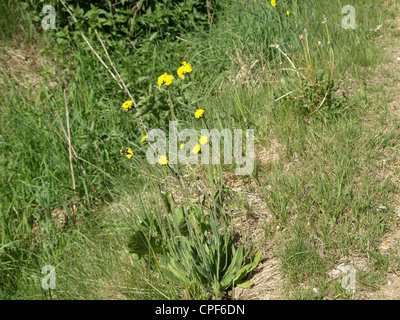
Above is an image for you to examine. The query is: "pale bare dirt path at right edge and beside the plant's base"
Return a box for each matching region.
[235,12,400,300]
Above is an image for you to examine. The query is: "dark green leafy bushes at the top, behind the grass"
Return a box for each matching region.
[29,0,212,48]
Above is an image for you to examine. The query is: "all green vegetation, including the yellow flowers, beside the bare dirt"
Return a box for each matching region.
[0,0,398,299]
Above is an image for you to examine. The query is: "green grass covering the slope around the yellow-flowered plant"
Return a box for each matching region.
[0,0,397,299]
